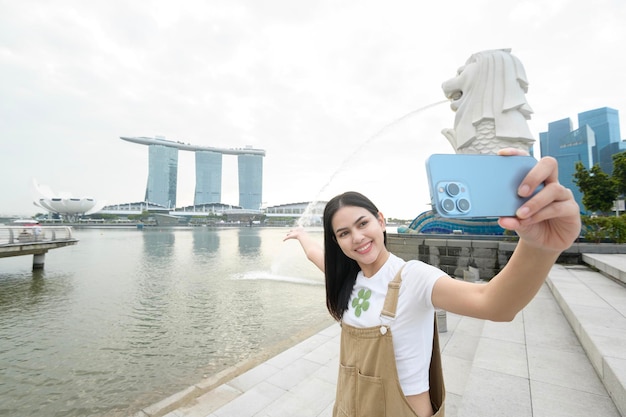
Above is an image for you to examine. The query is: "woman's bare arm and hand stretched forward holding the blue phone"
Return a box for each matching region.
[432,150,581,321]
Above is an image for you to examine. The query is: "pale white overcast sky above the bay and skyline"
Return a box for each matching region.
[0,0,626,219]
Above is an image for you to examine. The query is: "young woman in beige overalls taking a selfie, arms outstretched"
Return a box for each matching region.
[285,149,581,417]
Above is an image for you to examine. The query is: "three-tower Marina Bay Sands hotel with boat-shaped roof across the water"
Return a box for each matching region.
[120,136,265,210]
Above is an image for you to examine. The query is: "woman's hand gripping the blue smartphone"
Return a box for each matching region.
[498,149,581,252]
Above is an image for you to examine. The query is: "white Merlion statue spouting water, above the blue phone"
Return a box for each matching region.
[441,49,535,154]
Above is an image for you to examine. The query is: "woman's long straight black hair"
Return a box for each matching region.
[324,191,387,321]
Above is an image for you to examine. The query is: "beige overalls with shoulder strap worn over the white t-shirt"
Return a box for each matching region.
[333,269,446,417]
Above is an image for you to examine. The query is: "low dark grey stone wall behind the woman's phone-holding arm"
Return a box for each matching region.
[387,233,626,280]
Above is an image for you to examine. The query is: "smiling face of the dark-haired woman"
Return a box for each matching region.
[332,206,389,277]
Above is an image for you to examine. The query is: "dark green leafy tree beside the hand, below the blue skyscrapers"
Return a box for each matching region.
[574,161,618,212]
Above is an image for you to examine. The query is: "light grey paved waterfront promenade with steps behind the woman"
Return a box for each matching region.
[135,255,626,417]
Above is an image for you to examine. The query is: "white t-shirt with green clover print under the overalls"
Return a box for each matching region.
[342,254,445,395]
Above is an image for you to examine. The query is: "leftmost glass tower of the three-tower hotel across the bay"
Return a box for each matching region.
[144,145,178,208]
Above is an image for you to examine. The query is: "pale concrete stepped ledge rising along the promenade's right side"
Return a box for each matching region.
[547,265,626,416]
